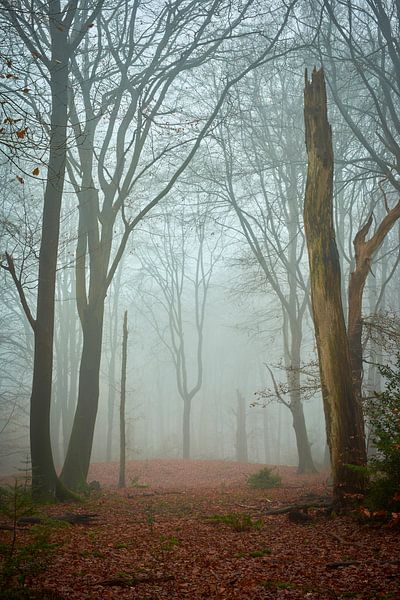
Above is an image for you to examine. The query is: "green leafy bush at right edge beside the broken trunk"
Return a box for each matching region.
[366,353,400,512]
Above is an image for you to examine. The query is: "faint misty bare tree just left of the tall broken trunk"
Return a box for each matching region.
[202,66,315,472]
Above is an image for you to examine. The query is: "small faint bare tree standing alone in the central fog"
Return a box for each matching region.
[140,204,223,458]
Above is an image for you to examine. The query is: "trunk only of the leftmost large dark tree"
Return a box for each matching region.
[30,16,69,499]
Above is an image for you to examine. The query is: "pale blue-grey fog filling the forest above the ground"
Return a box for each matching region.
[0,0,400,486]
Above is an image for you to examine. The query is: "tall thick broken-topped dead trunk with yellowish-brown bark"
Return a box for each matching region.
[304,69,366,506]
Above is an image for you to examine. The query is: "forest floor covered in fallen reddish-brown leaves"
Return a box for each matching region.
[0,460,400,600]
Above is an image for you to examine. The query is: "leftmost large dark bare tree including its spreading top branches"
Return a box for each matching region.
[0,0,102,498]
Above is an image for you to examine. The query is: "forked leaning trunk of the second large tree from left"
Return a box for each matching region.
[61,164,110,489]
